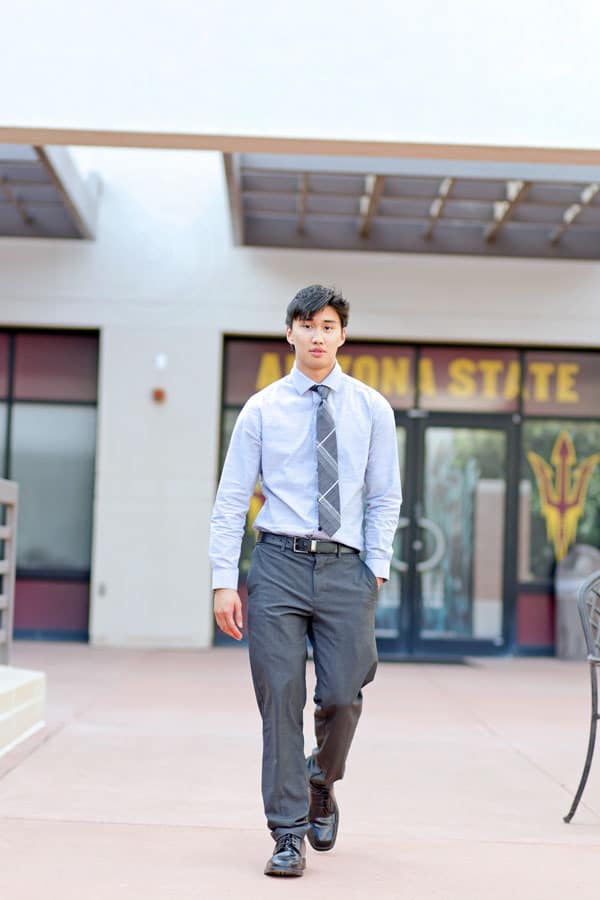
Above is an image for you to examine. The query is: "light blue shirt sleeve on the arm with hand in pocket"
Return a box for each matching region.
[365,396,402,580]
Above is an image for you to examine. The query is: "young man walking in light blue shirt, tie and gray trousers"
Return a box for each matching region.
[210,285,401,876]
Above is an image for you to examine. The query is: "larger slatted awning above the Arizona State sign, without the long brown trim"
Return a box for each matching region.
[224,153,600,260]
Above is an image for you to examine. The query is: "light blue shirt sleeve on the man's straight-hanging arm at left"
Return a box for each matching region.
[209,397,261,590]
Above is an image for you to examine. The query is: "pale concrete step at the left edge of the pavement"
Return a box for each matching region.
[0,666,46,756]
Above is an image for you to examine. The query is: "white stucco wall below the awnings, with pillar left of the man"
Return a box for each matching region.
[0,150,600,646]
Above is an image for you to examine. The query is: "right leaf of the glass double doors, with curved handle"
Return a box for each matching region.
[411,415,510,654]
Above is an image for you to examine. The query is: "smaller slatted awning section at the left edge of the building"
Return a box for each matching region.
[0,144,100,238]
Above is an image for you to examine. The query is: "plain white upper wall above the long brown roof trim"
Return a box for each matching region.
[0,0,600,148]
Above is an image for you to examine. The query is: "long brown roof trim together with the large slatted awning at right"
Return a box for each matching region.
[0,126,600,260]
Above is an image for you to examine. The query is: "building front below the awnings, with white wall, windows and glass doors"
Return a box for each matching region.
[0,149,600,656]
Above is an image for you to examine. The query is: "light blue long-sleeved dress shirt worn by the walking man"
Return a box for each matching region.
[209,363,402,590]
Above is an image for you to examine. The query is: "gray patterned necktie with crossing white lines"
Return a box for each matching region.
[311,384,341,537]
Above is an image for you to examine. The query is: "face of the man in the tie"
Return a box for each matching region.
[287,306,346,378]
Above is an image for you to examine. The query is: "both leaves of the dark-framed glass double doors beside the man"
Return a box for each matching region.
[376,413,516,656]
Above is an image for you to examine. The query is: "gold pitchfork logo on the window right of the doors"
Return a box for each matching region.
[527,431,600,560]
